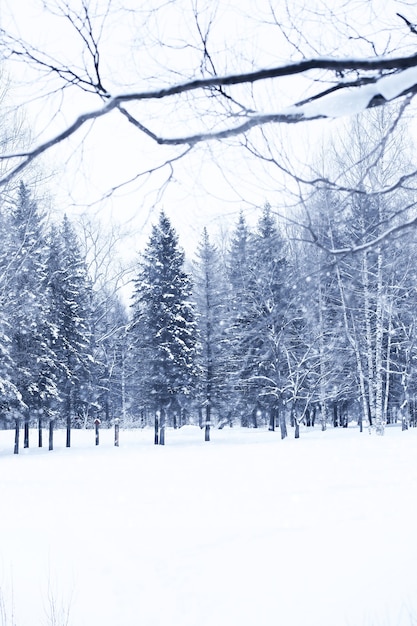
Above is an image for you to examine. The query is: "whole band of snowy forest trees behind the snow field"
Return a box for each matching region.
[0,107,417,445]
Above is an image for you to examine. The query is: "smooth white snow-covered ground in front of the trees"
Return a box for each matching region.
[0,420,417,626]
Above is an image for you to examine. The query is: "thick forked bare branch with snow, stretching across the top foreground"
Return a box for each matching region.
[0,48,417,185]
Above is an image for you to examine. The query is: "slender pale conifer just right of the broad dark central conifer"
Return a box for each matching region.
[194,228,229,441]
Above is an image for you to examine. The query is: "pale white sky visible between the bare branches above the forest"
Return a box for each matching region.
[0,0,417,260]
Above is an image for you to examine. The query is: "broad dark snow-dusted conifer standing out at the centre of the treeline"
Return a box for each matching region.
[130,211,196,444]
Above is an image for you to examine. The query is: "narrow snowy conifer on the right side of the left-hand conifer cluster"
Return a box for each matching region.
[48,216,94,447]
